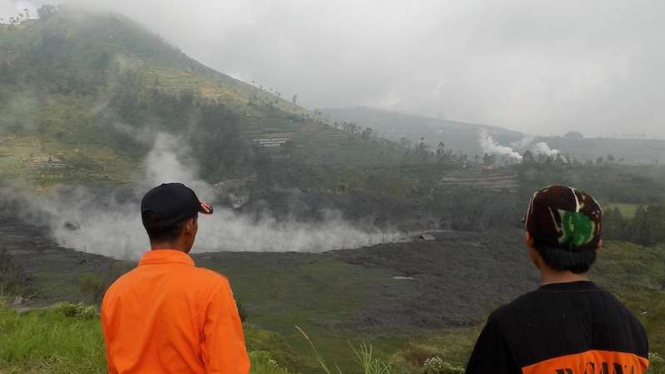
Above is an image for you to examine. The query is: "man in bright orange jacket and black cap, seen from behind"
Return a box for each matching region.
[101,183,250,374]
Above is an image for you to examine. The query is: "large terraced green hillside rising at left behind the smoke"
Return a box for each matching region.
[0,6,399,185]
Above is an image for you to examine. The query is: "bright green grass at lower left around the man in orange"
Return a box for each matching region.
[0,304,296,374]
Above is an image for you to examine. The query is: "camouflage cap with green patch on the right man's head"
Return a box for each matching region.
[524,186,603,252]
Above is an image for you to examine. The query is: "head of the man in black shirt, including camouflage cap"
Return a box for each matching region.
[524,186,602,274]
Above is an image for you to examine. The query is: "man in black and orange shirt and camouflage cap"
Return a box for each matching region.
[466,186,649,374]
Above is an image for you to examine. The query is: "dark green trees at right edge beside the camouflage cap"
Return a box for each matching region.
[604,205,665,247]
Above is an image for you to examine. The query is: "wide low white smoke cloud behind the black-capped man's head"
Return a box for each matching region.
[10,134,404,260]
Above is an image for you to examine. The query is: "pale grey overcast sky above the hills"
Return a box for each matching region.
[0,0,665,137]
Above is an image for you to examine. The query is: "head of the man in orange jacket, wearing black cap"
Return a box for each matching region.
[141,183,212,253]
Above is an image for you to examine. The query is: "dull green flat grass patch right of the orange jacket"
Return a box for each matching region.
[197,253,408,372]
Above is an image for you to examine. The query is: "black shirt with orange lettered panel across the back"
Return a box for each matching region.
[466,281,649,374]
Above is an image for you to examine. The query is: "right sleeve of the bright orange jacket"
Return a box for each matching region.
[202,279,250,374]
